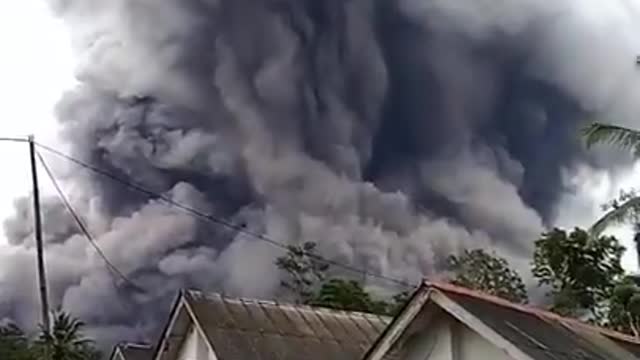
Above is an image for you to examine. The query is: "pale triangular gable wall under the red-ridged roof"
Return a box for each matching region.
[401,316,513,360]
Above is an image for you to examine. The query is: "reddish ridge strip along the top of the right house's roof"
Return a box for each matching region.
[424,280,640,345]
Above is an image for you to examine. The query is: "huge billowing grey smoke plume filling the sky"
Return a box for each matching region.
[0,0,640,348]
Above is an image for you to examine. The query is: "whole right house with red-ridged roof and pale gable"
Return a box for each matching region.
[363,283,640,360]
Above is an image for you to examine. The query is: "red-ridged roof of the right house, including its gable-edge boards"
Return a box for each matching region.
[364,281,640,360]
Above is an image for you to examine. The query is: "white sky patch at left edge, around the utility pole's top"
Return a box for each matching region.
[0,0,74,249]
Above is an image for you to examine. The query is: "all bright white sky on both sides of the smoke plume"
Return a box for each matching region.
[0,0,640,270]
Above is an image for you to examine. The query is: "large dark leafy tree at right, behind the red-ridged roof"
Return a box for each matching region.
[532,228,625,323]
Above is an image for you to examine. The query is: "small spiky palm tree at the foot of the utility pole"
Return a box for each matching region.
[36,311,100,360]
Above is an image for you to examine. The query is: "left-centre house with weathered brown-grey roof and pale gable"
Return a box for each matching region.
[152,291,398,360]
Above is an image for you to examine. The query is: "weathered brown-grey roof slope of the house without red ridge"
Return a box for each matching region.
[182,291,398,360]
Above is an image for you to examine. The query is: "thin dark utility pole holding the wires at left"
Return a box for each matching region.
[28,135,51,333]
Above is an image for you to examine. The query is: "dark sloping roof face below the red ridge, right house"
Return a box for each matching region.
[428,284,640,360]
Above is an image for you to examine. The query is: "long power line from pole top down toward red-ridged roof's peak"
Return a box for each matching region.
[36,143,415,288]
